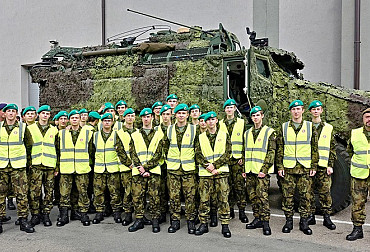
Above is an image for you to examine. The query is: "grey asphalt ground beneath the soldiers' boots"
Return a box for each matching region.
[0,179,370,252]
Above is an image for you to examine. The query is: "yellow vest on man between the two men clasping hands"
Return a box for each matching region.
[166,124,196,171]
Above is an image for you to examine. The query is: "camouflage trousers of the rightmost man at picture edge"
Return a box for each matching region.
[351,176,370,226]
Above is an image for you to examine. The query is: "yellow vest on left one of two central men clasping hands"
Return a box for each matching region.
[131,130,163,176]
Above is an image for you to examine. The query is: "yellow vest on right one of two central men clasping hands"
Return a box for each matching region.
[199,130,229,177]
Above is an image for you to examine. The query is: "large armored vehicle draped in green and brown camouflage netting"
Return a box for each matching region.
[31,10,370,215]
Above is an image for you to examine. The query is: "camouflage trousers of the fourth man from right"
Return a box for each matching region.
[246,173,270,221]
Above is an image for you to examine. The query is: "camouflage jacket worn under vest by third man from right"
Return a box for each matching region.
[276,120,319,174]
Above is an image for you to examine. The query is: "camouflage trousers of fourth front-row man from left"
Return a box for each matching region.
[94,172,122,213]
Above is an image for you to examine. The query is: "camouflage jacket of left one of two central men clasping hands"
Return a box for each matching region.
[130,128,162,171]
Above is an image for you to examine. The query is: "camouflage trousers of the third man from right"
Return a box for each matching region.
[281,172,312,218]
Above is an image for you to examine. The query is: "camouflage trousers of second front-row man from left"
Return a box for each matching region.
[28,166,54,214]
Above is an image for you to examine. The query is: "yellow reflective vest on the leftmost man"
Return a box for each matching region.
[0,122,27,168]
